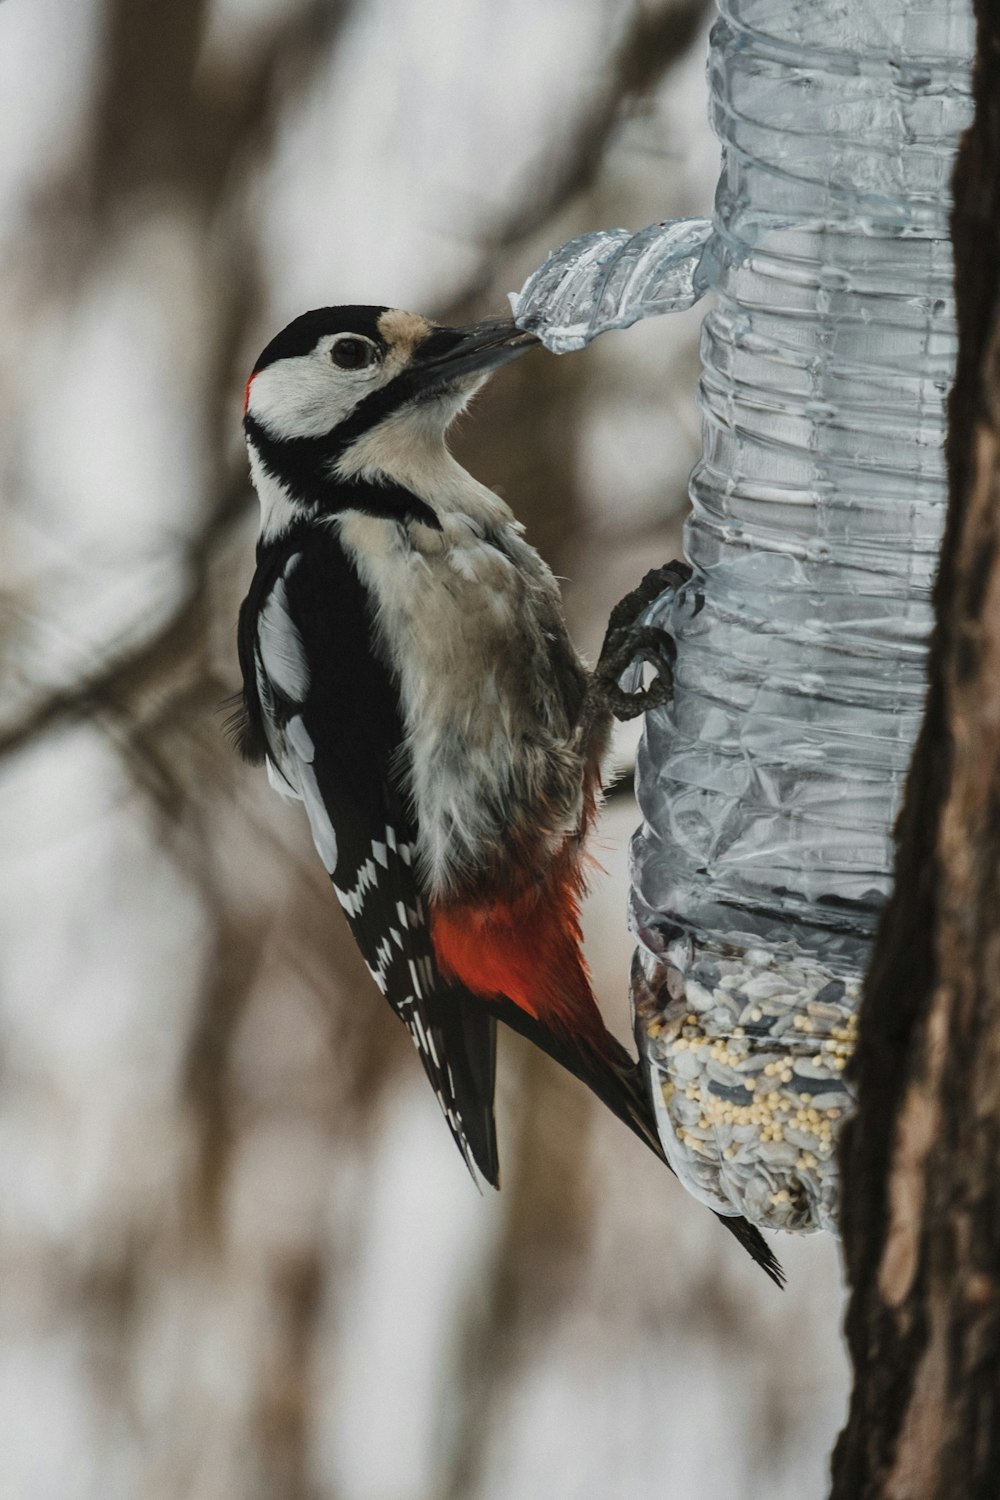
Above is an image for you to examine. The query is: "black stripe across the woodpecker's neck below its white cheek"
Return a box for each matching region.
[243,413,441,531]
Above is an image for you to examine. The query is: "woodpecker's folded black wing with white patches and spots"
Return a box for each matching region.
[240,528,499,1187]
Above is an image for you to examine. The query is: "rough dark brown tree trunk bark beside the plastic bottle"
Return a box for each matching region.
[832,0,1000,1500]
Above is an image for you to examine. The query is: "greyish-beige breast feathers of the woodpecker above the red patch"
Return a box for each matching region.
[335,513,586,896]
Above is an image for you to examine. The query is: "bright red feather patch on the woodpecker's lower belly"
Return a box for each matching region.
[430,888,604,1038]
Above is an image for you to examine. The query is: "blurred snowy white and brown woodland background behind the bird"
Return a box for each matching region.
[0,0,846,1500]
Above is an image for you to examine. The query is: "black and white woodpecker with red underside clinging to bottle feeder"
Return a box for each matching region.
[237,306,781,1283]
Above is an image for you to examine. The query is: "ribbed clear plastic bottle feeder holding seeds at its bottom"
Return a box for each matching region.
[519,0,975,1229]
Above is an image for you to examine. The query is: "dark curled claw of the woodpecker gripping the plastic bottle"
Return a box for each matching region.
[591,563,691,722]
